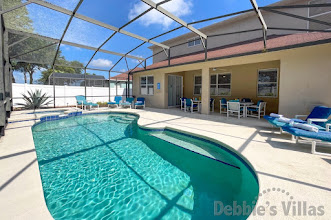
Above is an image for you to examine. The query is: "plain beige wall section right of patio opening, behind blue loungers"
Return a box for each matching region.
[279,44,331,116]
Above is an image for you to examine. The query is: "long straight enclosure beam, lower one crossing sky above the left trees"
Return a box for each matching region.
[8,29,144,60]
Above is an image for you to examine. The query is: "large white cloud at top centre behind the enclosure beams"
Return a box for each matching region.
[129,0,193,28]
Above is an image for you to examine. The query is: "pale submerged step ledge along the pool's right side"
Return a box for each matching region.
[150,133,240,169]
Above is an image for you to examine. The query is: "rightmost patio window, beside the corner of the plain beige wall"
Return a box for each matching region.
[257,69,278,97]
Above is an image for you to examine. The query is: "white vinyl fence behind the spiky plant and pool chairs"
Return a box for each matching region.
[13,83,132,107]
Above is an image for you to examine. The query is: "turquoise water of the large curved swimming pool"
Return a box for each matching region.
[32,113,258,219]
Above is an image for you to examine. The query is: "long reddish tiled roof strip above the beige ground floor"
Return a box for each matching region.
[134,32,331,72]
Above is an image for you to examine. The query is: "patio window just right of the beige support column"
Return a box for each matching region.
[210,73,231,96]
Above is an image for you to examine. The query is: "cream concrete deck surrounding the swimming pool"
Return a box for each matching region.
[0,108,331,219]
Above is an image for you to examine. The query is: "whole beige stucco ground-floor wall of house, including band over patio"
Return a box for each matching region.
[133,43,331,117]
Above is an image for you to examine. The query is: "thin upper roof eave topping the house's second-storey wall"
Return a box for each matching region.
[148,0,305,50]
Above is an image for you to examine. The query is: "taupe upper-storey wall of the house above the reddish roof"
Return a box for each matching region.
[150,0,331,63]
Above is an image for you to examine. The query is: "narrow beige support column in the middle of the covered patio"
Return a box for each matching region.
[201,67,210,115]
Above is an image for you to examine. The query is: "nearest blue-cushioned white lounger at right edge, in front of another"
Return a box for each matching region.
[283,124,331,156]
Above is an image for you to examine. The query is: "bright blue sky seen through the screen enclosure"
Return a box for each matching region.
[14,0,276,83]
